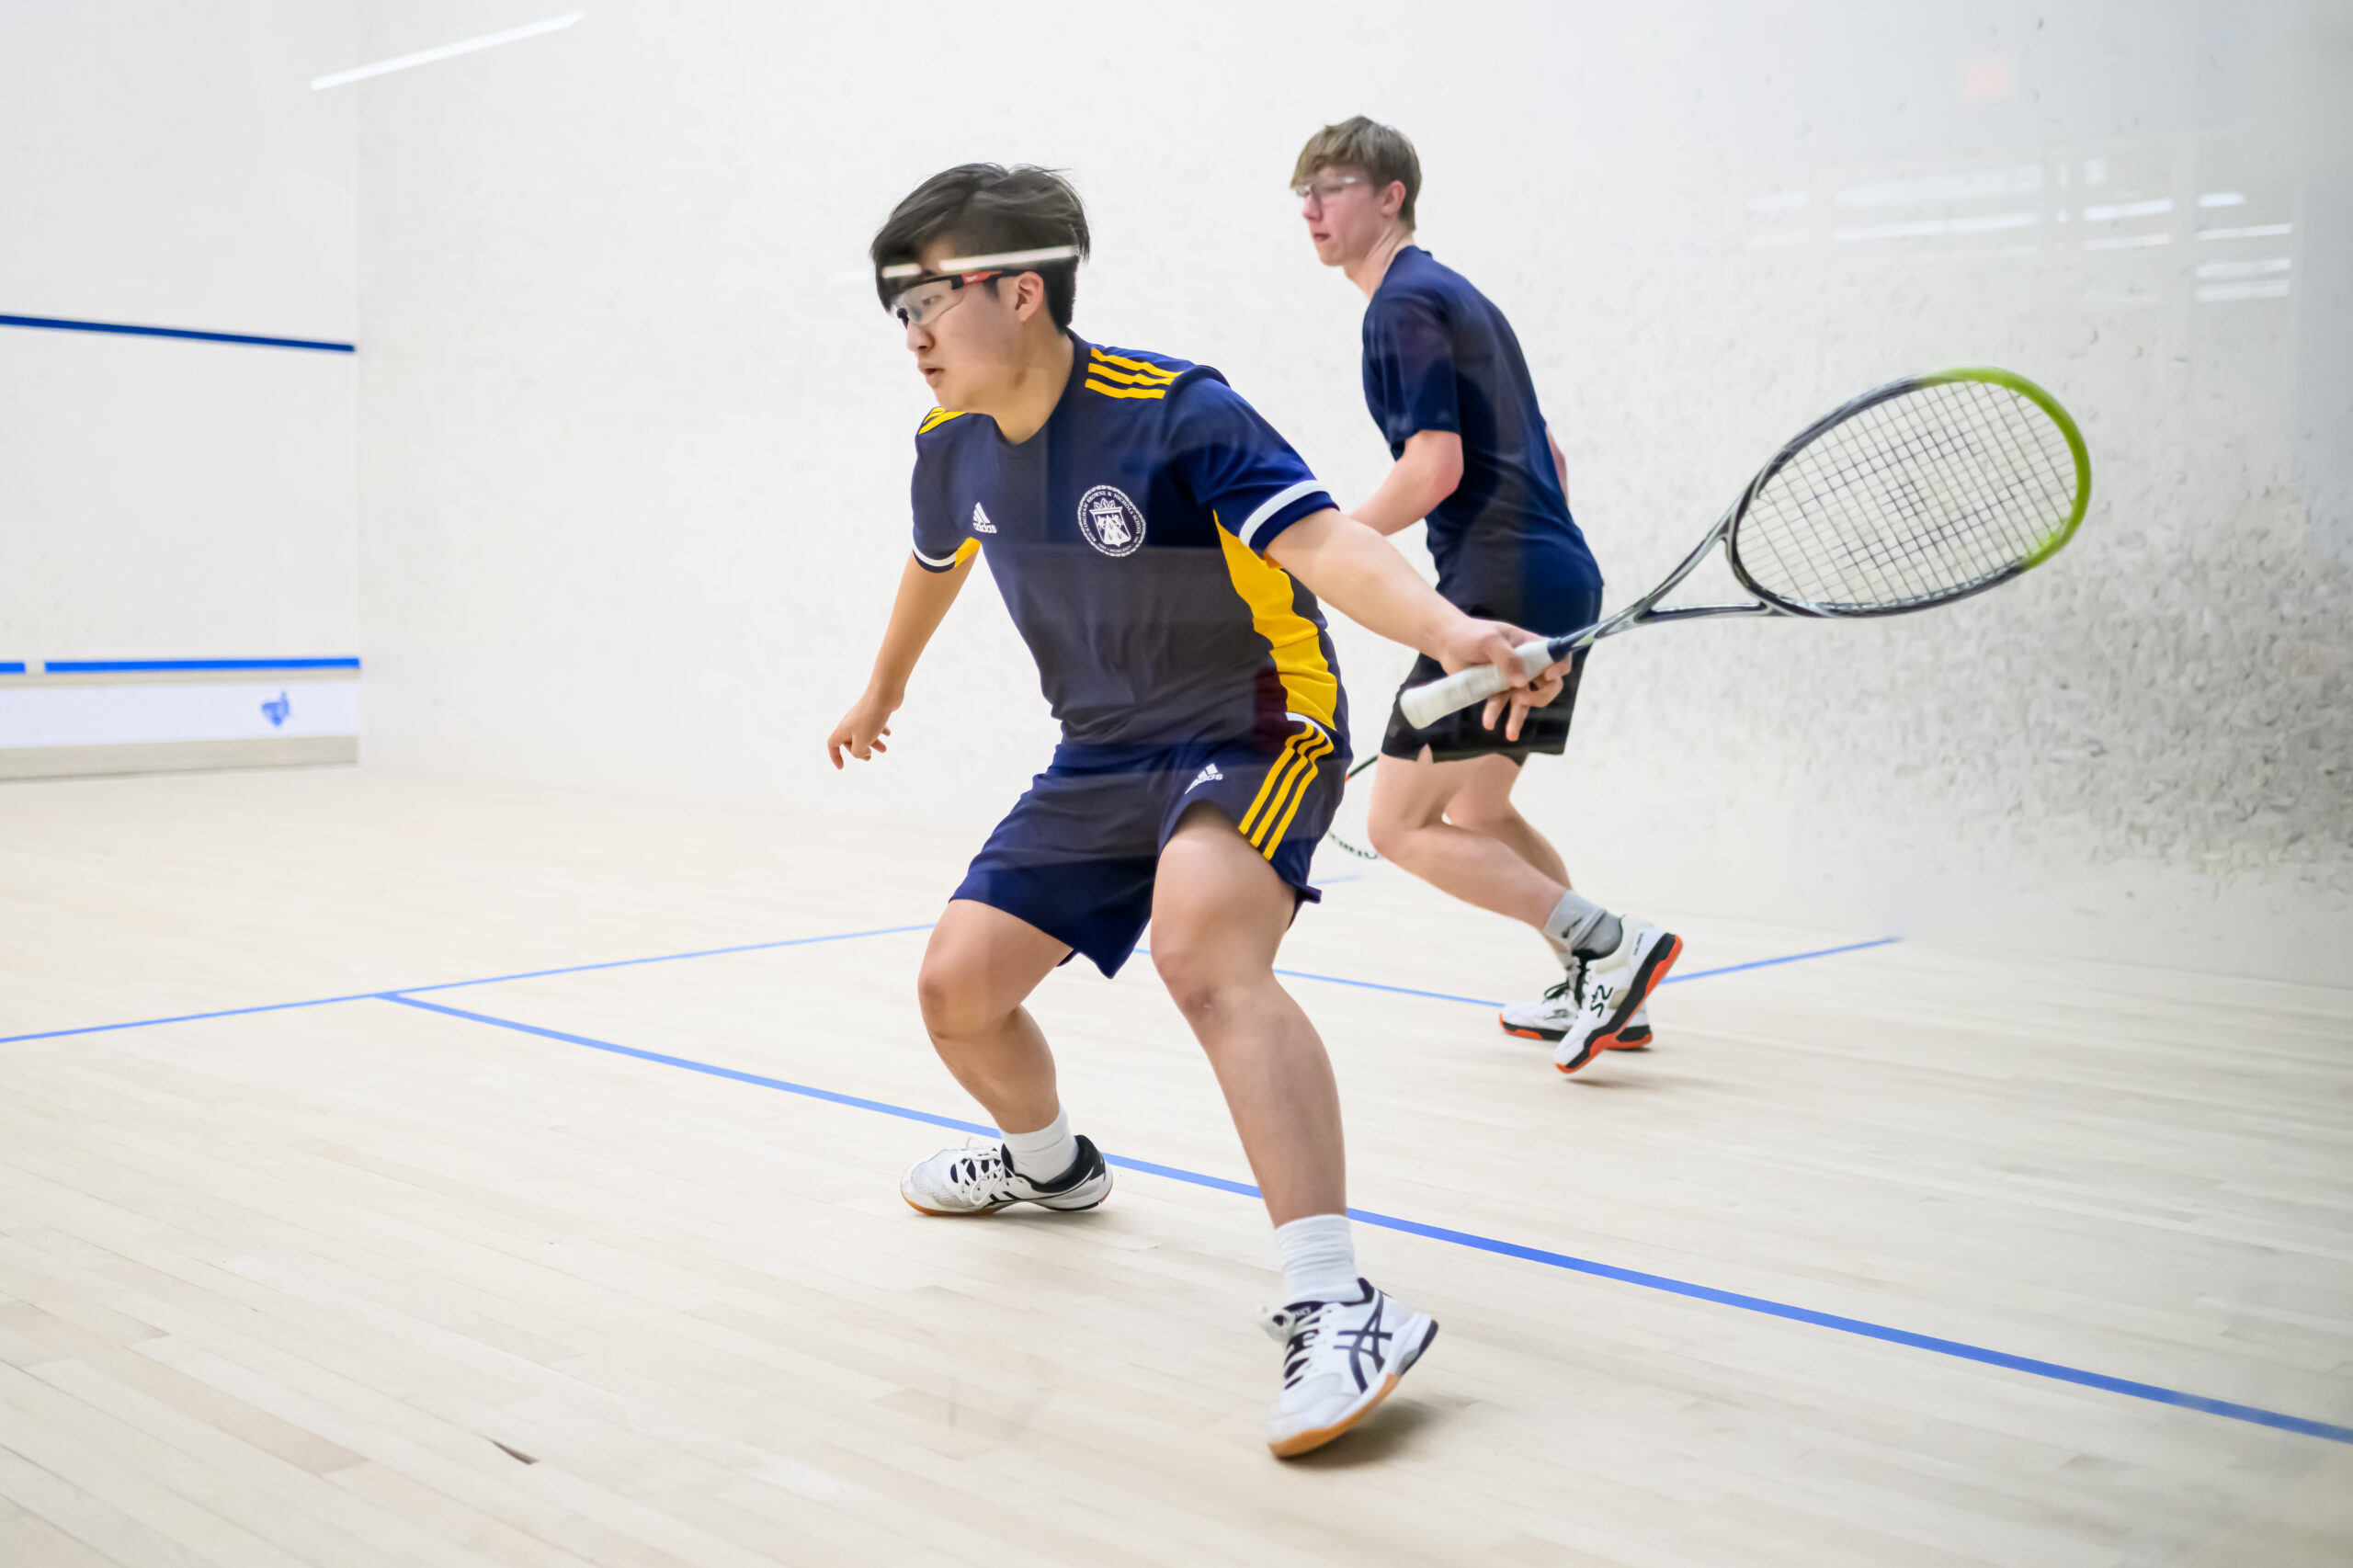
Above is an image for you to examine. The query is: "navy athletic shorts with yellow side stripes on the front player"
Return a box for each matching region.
[950,721,1348,974]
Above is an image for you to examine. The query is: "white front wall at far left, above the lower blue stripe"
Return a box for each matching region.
[0,0,358,659]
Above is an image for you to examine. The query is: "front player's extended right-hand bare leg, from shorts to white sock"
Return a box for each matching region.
[1153,805,1348,1227]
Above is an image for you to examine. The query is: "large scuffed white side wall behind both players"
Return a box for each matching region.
[358,0,2353,980]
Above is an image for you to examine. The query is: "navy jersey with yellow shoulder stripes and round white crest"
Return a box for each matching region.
[915,336,1348,746]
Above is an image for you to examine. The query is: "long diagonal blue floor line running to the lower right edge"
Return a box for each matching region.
[381,988,2353,1443]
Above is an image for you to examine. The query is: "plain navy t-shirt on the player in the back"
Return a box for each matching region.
[1365,244,1600,636]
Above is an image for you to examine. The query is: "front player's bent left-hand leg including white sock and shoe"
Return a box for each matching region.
[899,900,1110,1215]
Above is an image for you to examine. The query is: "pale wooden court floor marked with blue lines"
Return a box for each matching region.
[0,770,2353,1568]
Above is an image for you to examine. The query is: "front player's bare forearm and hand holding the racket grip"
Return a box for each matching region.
[1266,511,1567,734]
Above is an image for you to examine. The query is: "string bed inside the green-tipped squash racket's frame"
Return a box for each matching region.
[1736,381,2077,609]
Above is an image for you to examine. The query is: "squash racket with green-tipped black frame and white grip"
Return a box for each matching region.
[1400,369,2092,728]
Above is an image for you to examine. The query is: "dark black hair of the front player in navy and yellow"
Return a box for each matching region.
[866,163,1087,330]
